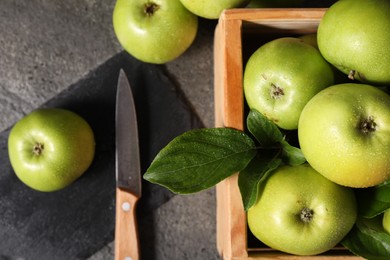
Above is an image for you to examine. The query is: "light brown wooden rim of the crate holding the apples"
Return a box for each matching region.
[214,8,362,260]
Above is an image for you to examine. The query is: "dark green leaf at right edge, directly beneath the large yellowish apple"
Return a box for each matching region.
[355,183,390,218]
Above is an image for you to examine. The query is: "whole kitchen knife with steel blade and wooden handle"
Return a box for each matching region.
[115,69,141,260]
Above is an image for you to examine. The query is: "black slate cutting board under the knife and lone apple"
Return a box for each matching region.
[0,52,202,260]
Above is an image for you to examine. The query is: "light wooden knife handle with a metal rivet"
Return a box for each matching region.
[114,188,140,260]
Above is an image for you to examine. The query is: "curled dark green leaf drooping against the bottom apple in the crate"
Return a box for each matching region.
[238,154,282,211]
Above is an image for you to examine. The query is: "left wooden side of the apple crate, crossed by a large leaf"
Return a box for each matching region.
[214,9,247,257]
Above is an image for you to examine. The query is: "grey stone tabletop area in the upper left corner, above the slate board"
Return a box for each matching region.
[0,0,121,130]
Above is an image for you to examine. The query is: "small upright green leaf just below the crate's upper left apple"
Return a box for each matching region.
[247,109,283,147]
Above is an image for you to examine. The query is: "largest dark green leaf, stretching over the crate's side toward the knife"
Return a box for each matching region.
[143,128,256,194]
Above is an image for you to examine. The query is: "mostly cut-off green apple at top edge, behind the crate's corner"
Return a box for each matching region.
[180,0,249,19]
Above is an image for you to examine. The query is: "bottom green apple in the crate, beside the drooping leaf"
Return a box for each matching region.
[247,164,357,255]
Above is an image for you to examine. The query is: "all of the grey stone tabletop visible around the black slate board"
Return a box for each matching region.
[0,0,219,260]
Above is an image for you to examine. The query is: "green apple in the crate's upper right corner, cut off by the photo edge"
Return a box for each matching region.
[317,0,390,85]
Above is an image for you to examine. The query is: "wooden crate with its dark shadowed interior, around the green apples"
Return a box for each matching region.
[214,8,361,259]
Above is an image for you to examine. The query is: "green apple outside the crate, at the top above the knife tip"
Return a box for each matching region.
[113,0,198,64]
